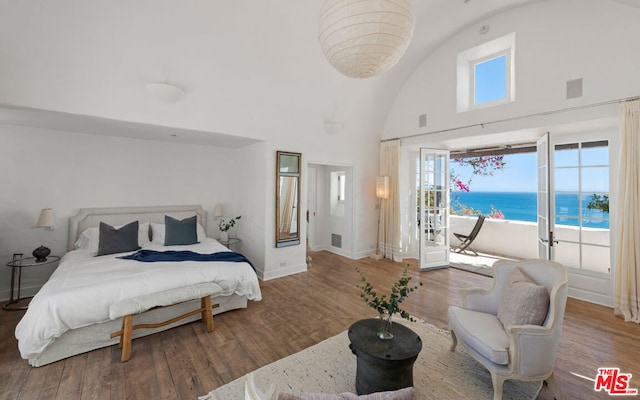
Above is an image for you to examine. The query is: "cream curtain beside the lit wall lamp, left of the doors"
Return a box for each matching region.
[378,140,402,261]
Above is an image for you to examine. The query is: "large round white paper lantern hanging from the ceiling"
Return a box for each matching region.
[318,0,415,78]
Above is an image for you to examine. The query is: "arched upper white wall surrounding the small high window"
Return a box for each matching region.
[383,0,640,140]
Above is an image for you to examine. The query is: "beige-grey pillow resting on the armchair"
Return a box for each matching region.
[498,268,549,326]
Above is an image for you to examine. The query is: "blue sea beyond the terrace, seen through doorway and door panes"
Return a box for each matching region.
[451,191,609,229]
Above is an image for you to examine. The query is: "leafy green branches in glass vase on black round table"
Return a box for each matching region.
[356,268,422,339]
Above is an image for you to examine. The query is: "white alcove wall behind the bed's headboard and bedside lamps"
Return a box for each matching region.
[0,125,241,299]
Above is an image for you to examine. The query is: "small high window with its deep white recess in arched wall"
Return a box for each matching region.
[457,33,516,112]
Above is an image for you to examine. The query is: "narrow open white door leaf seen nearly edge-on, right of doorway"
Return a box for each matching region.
[537,133,553,260]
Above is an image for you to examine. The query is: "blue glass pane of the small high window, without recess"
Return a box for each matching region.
[473,54,507,104]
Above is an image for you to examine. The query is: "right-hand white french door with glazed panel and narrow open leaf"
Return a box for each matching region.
[538,134,613,305]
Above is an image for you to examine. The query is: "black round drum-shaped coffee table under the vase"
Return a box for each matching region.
[348,318,422,395]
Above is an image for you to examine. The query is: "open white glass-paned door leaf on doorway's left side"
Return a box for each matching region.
[418,148,450,270]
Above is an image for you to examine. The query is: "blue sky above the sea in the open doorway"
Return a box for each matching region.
[450,153,538,192]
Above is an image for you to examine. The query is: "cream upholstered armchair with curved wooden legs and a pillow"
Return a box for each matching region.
[449,260,568,400]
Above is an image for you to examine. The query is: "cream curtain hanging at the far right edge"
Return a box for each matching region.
[613,100,640,323]
